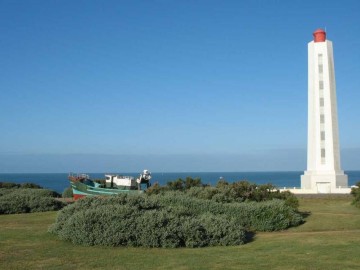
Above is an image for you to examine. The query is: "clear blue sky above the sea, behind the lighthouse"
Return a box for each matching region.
[0,0,360,172]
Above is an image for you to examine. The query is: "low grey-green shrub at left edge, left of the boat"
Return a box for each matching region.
[0,187,64,214]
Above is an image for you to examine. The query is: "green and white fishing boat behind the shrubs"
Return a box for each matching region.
[68,170,151,200]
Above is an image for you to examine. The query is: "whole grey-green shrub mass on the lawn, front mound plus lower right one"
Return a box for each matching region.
[49,192,302,247]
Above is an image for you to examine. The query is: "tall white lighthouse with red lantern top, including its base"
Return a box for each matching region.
[301,29,348,193]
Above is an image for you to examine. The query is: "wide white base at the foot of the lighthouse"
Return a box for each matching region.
[301,171,348,193]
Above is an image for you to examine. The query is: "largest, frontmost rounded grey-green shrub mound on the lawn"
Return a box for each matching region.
[49,194,246,248]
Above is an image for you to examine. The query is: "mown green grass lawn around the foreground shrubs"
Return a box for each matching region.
[0,196,360,270]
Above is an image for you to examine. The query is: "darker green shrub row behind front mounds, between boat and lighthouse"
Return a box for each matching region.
[146,177,299,209]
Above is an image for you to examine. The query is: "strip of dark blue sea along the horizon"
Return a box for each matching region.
[0,171,360,193]
